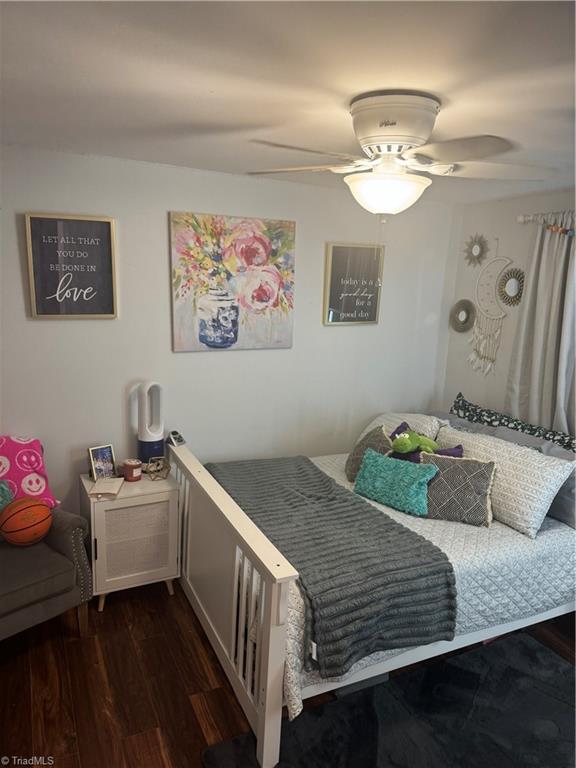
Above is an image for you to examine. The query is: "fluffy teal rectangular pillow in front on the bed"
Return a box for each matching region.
[354,448,438,517]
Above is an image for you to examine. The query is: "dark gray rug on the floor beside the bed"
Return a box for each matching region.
[203,634,574,768]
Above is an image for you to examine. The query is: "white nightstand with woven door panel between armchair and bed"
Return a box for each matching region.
[80,475,180,611]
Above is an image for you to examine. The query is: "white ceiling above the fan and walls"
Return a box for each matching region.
[1,1,574,201]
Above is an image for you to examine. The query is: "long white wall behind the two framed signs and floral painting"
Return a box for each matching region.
[1,147,452,503]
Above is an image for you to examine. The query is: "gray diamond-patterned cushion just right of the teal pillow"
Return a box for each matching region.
[422,453,495,527]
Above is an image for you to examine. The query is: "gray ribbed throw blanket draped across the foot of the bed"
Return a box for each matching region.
[206,456,456,677]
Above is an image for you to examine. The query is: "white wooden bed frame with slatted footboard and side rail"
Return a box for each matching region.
[170,446,574,768]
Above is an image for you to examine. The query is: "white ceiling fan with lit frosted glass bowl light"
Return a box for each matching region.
[251,91,553,213]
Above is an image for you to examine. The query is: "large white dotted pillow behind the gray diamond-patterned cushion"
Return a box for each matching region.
[436,427,574,539]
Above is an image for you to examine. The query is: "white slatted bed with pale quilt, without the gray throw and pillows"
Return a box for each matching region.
[171,446,575,768]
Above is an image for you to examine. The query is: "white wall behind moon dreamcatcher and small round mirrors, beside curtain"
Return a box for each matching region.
[444,190,574,410]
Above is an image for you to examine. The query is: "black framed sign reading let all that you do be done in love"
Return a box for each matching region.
[26,213,116,318]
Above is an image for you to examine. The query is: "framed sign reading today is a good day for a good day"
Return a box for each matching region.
[324,243,384,325]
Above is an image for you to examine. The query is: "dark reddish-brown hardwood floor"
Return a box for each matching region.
[0,584,574,768]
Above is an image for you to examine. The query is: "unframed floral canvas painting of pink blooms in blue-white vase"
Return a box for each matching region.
[170,213,295,352]
